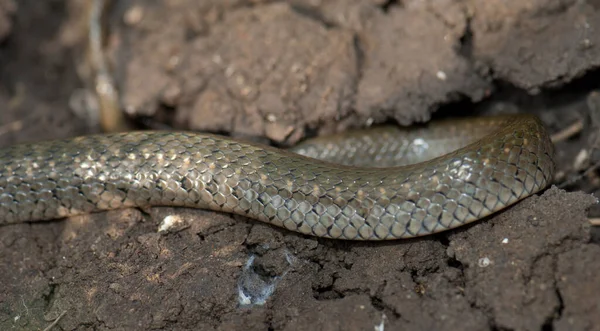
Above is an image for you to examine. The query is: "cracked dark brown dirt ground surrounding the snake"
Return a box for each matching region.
[0,0,600,331]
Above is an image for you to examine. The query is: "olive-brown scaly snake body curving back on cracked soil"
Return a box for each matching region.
[0,114,555,240]
